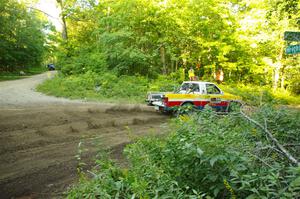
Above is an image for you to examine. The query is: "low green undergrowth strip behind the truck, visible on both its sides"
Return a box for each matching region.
[37,72,300,106]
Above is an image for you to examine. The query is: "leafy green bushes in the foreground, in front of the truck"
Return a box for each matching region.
[67,106,300,199]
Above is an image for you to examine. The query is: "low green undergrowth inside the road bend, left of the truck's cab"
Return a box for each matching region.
[37,72,178,103]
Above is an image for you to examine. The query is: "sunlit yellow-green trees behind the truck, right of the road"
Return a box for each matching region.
[50,0,299,94]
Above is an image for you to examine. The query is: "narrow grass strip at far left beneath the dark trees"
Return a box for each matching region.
[0,67,47,81]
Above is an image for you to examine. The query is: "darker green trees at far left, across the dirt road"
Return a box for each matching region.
[0,0,46,72]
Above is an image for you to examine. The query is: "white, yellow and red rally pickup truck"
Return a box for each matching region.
[153,81,241,112]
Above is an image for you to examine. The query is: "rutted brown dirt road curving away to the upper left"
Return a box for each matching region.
[0,73,167,199]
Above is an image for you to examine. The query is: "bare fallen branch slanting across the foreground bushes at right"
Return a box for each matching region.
[240,105,300,166]
